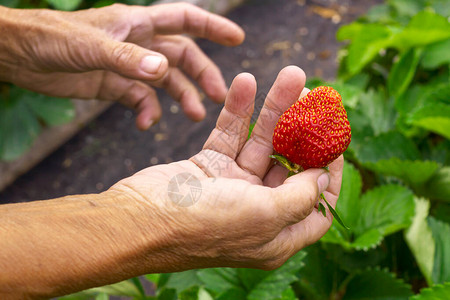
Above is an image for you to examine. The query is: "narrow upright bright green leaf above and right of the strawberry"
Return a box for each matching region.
[388,48,423,98]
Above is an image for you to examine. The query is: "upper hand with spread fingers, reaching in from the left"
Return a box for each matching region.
[0,3,244,130]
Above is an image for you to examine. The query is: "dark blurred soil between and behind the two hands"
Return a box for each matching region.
[0,0,381,203]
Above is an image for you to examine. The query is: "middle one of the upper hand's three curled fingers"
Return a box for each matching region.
[152,68,206,121]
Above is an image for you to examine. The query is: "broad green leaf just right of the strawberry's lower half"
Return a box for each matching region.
[356,131,421,163]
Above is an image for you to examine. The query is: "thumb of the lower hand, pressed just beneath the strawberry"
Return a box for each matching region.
[275,169,330,225]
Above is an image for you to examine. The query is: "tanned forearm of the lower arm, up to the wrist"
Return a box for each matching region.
[0,192,172,299]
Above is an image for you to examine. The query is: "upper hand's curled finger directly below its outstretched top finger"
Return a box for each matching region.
[152,36,227,103]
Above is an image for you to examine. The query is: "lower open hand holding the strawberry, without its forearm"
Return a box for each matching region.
[110,66,343,272]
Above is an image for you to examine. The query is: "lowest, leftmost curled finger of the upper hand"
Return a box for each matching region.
[95,72,162,130]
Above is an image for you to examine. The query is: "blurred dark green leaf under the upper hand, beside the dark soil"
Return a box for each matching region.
[22,92,75,126]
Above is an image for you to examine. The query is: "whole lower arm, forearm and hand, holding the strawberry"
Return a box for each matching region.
[0,67,343,299]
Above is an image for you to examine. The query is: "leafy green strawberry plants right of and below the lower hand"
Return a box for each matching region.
[37,0,450,300]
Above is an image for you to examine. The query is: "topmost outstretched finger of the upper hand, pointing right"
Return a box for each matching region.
[148,3,245,46]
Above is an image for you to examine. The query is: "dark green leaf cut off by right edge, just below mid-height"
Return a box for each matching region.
[421,167,450,203]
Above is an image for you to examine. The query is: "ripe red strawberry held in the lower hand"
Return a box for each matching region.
[273,86,351,170]
